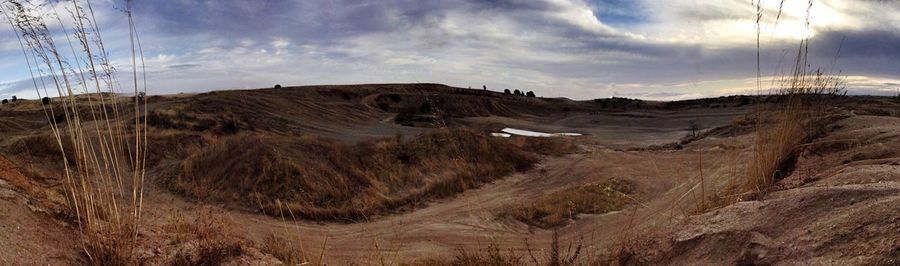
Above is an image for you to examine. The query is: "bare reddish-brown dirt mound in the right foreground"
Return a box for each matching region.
[628,116,900,265]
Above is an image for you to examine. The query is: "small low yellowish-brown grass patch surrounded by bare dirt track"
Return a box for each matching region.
[505,179,635,228]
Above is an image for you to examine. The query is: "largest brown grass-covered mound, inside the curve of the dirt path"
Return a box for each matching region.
[163,129,538,221]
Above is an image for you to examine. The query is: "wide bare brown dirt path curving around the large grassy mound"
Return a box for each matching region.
[141,140,729,264]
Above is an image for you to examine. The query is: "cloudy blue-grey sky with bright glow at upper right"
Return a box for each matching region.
[0,0,900,100]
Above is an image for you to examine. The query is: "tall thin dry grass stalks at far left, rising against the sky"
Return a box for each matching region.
[0,0,147,265]
